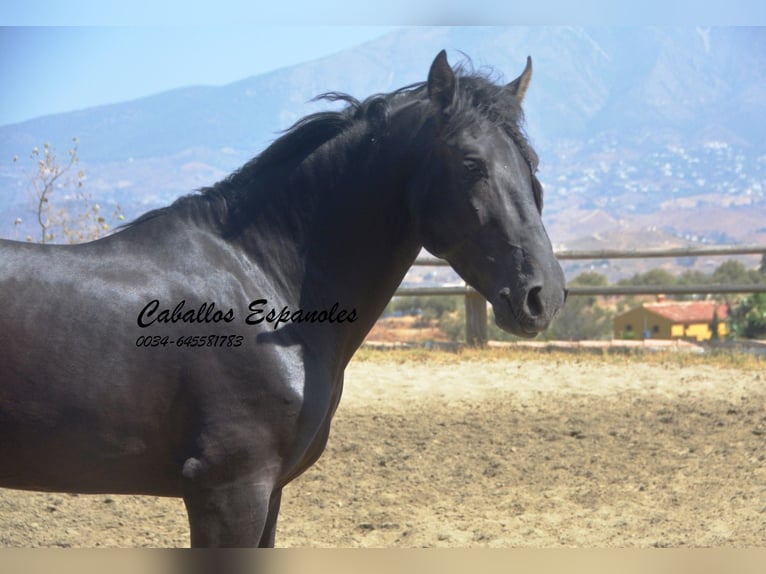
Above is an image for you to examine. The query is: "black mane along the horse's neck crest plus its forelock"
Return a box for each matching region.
[123,61,538,232]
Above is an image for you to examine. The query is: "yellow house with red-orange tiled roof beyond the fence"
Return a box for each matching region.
[614,301,728,341]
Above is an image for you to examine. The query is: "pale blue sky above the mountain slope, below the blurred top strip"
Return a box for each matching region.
[0,26,402,125]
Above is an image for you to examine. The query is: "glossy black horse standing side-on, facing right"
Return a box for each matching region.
[0,51,565,546]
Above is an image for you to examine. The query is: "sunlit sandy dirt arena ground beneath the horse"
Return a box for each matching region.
[0,351,766,547]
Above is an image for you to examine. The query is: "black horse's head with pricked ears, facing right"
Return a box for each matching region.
[412,51,566,337]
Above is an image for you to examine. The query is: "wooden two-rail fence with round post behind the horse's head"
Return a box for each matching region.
[395,245,766,345]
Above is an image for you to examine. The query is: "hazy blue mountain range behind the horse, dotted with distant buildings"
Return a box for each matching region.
[0,27,766,276]
